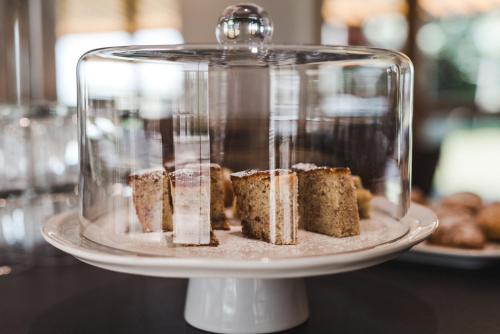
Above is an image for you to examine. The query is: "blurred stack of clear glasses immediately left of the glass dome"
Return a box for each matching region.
[26,105,79,265]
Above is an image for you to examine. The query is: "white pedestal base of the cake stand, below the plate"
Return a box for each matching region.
[184,278,309,333]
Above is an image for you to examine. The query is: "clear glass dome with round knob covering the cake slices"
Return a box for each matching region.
[78,5,413,258]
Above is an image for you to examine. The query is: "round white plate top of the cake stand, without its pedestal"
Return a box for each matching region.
[42,205,437,278]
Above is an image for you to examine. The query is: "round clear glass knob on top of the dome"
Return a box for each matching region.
[215,3,273,44]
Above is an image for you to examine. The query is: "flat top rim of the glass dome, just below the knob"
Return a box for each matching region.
[78,43,413,67]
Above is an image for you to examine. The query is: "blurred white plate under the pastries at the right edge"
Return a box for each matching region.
[400,241,500,269]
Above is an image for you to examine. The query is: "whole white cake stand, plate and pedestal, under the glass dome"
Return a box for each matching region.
[42,204,437,333]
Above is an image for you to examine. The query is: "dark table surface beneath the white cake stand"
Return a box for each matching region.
[0,250,500,334]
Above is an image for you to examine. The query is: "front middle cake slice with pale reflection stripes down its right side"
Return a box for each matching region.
[231,169,299,245]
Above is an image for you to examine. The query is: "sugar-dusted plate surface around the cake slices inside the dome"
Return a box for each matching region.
[83,200,409,261]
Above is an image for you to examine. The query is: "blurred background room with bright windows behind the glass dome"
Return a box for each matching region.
[0,0,500,272]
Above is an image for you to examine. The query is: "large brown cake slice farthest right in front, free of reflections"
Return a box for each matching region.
[294,164,359,237]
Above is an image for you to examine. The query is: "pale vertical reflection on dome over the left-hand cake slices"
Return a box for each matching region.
[172,68,211,245]
